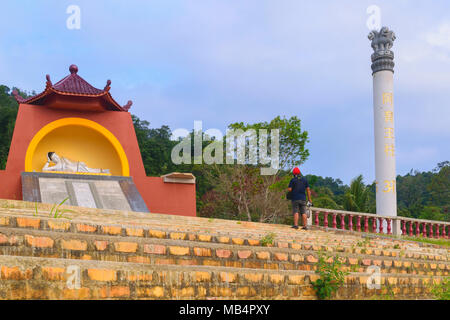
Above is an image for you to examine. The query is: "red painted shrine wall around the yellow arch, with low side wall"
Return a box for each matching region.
[0,102,196,216]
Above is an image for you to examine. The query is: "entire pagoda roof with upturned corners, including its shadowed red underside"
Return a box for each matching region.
[13,64,132,111]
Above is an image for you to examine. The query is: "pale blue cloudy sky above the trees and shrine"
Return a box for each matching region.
[0,0,450,183]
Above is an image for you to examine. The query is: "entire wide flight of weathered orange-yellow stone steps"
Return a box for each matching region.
[0,200,450,299]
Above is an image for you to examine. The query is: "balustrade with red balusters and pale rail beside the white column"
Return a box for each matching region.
[309,208,450,239]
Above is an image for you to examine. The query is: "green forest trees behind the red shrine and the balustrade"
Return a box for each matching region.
[0,85,450,223]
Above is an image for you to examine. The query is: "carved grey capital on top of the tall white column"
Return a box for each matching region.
[368,27,396,73]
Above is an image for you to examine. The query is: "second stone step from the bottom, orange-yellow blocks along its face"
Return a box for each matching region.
[0,227,450,276]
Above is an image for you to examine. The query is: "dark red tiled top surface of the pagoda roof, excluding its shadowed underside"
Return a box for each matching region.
[13,64,132,111]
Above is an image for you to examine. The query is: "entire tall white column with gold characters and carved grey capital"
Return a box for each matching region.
[369,27,397,232]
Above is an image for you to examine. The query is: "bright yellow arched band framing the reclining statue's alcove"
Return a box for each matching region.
[25,118,130,176]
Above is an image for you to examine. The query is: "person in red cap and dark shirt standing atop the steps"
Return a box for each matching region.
[288,167,312,230]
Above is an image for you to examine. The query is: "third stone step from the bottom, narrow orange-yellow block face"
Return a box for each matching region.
[0,212,448,260]
